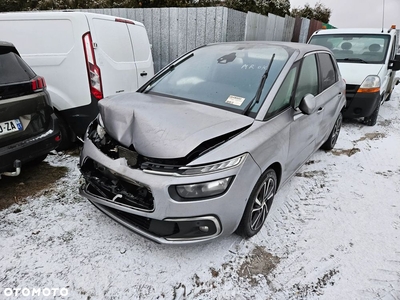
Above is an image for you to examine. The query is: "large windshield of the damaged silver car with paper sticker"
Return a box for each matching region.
[144,43,292,114]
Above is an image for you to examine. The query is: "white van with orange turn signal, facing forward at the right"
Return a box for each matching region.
[308,26,400,126]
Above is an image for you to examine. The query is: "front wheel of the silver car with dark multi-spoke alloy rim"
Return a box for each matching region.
[236,169,278,238]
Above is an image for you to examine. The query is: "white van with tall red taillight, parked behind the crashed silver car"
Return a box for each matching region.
[0,12,154,148]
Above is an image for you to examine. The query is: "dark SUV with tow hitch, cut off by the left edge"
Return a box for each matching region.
[0,41,61,177]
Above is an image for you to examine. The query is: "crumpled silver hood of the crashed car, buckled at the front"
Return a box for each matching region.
[99,93,254,159]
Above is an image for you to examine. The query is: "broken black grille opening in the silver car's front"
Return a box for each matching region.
[81,158,154,212]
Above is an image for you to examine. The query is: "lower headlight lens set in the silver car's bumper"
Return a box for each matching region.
[176,177,232,199]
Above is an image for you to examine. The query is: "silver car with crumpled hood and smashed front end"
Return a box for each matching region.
[80,42,346,244]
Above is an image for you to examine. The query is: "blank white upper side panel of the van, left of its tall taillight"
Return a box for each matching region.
[0,20,74,56]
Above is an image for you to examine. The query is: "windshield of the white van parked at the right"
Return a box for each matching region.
[310,34,390,64]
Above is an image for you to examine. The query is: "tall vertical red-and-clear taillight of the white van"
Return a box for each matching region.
[82,32,103,100]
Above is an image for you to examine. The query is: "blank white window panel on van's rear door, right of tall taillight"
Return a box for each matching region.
[92,18,133,63]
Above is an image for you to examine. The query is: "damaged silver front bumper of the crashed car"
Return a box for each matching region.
[80,139,261,244]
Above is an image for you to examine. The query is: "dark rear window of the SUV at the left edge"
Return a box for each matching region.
[0,52,36,85]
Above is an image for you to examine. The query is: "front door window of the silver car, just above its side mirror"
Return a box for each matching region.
[294,54,318,108]
